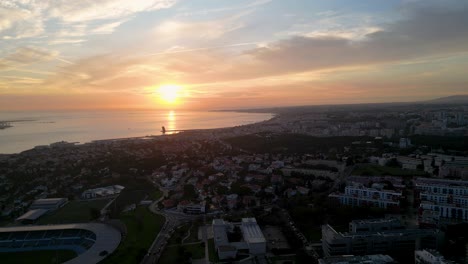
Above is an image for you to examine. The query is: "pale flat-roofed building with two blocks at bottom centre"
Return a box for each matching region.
[212,218,266,260]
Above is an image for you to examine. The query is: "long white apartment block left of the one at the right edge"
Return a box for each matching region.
[328,182,402,209]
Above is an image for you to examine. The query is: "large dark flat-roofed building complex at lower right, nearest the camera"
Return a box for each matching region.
[322,219,443,257]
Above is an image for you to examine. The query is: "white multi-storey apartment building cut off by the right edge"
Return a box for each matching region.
[415,178,468,224]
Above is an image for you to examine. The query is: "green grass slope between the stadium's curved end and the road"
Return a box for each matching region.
[102,206,165,264]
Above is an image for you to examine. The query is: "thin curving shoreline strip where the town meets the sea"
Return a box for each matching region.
[0,110,280,156]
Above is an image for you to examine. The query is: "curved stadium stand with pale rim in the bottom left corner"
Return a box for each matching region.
[0,223,121,264]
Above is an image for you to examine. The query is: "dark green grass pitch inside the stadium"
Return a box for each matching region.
[0,250,77,264]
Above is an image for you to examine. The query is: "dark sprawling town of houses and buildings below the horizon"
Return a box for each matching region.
[0,101,468,264]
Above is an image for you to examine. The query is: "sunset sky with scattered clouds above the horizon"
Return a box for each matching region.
[0,0,468,111]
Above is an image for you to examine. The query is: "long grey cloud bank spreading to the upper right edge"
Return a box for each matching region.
[205,1,468,79]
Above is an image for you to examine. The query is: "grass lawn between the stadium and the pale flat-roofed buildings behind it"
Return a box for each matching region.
[38,199,110,225]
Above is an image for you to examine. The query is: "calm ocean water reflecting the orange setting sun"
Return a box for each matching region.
[0,110,273,154]
